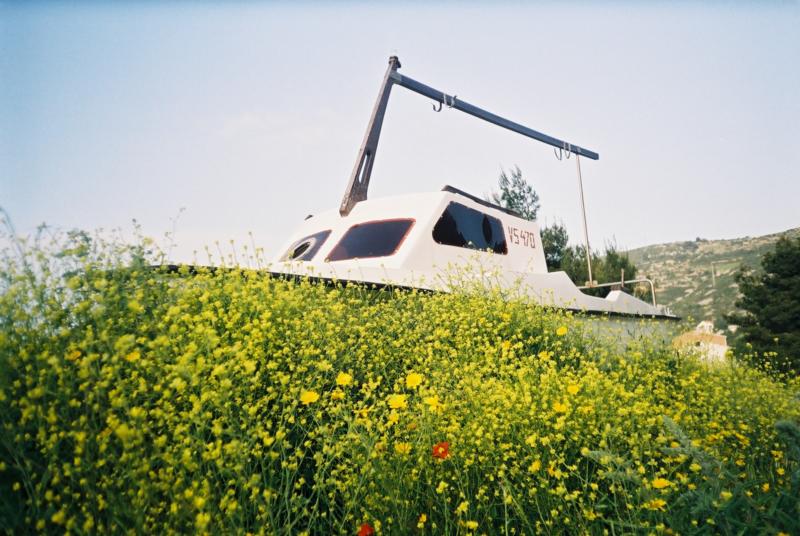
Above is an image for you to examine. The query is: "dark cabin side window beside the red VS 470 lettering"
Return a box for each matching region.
[433,201,508,255]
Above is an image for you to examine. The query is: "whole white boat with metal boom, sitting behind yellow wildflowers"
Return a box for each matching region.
[271,57,677,320]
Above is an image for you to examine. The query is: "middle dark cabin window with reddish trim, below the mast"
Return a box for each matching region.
[326,220,414,261]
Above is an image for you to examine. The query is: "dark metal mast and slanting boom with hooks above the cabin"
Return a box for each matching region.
[339,56,600,216]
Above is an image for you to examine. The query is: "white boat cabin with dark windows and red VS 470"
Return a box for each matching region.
[278,186,547,276]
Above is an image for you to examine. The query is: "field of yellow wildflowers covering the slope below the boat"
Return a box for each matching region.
[0,235,800,535]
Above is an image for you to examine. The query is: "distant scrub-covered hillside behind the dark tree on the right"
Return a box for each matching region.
[628,227,800,328]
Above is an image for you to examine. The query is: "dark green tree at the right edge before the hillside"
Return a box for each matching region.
[725,237,800,374]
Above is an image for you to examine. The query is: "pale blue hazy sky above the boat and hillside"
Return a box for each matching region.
[0,2,800,259]
